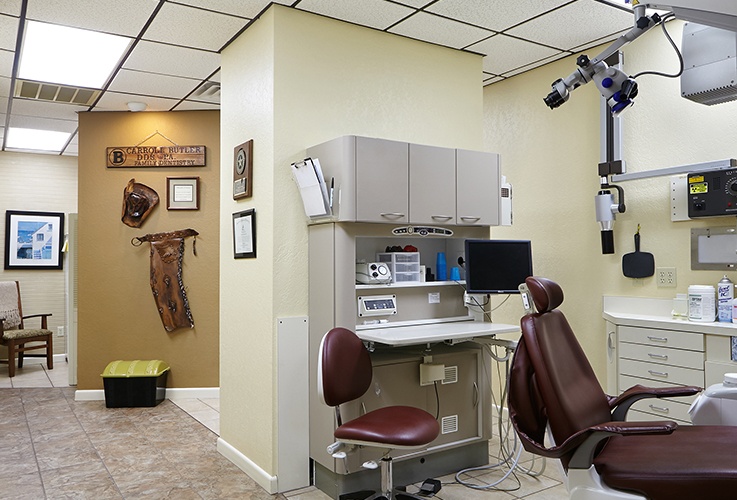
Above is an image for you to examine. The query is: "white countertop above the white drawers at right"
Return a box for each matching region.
[602,295,737,336]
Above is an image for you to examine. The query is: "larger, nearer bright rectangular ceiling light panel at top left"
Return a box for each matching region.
[18,21,130,89]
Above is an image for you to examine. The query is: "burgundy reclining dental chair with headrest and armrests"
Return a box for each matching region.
[508,277,737,500]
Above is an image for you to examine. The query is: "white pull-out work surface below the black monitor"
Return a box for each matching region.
[356,321,519,346]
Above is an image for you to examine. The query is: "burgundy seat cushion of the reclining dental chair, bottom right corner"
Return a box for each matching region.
[594,425,737,500]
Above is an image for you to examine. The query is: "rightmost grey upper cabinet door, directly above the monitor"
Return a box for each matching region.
[456,149,501,226]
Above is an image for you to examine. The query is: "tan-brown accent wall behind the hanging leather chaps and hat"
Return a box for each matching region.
[78,111,220,389]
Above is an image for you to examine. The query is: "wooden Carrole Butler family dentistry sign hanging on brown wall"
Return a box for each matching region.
[106,146,205,168]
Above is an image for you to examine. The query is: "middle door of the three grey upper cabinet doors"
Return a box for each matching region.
[409,144,456,224]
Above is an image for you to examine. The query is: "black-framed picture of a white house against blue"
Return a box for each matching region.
[5,210,64,269]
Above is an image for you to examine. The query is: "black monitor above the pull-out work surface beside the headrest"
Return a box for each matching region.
[464,240,532,293]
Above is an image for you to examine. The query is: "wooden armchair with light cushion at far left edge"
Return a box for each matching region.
[0,281,54,377]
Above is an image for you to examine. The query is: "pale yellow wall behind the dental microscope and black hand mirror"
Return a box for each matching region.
[484,22,737,385]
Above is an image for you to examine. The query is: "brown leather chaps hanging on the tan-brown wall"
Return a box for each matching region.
[131,229,199,332]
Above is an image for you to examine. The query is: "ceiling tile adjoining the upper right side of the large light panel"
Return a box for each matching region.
[123,40,220,80]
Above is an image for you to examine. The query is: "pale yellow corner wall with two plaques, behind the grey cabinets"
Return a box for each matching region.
[220,2,482,475]
